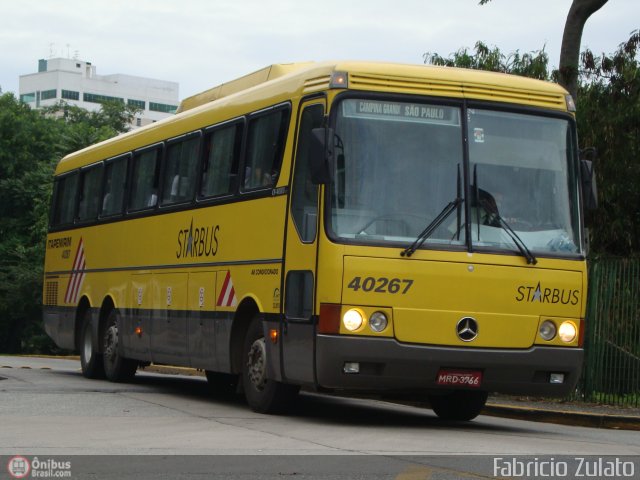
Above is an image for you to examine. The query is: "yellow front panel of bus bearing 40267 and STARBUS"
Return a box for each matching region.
[341,249,584,348]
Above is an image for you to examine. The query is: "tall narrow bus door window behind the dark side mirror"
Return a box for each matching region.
[291,105,324,242]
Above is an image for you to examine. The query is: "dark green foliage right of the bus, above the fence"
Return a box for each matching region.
[577,31,640,256]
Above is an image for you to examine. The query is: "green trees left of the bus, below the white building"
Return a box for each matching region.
[0,93,135,353]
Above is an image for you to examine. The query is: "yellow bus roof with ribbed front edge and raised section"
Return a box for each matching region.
[56,61,567,174]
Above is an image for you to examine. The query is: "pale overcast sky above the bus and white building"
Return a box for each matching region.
[0,0,640,99]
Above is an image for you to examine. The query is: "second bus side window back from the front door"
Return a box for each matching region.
[200,124,242,197]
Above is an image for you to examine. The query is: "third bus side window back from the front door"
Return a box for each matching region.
[162,136,200,205]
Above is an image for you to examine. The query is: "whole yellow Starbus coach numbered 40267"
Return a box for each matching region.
[43,62,591,420]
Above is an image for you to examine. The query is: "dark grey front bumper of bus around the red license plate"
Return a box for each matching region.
[316,335,584,397]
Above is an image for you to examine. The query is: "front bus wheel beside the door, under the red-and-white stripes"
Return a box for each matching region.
[242,315,300,413]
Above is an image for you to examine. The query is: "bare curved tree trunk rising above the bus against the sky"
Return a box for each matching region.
[559,0,608,100]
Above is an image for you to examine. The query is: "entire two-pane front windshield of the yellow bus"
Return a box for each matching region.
[328,98,581,256]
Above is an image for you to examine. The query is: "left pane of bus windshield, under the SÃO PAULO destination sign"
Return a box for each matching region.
[331,99,465,245]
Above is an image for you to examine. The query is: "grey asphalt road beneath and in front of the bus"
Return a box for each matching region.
[0,356,640,479]
